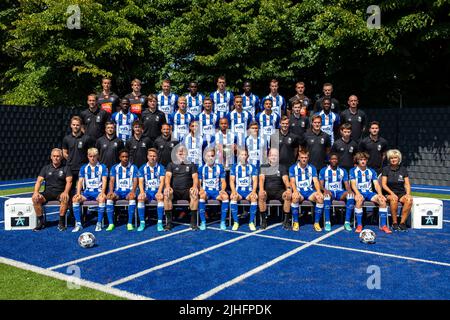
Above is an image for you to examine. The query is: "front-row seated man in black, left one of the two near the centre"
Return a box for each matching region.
[164,144,198,230]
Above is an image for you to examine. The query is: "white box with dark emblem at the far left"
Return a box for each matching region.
[4,198,37,230]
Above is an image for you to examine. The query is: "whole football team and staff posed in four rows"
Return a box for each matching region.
[32,76,412,234]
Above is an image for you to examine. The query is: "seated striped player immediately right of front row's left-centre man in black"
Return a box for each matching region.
[198,148,228,230]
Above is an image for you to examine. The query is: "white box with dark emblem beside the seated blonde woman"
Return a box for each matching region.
[411,197,444,229]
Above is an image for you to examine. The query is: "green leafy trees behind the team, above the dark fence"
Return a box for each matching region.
[0,0,450,107]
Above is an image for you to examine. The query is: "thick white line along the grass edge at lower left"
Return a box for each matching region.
[0,257,153,300]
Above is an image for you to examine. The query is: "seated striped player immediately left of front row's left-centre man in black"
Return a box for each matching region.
[138,148,166,231]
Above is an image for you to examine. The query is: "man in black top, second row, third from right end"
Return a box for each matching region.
[305,115,331,172]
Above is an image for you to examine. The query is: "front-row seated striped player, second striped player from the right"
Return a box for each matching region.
[319,153,355,231]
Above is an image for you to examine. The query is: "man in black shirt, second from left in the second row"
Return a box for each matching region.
[95,121,125,170]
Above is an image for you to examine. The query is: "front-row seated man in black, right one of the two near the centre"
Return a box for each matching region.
[258,148,292,230]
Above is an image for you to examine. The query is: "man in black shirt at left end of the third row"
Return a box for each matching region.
[80,94,110,140]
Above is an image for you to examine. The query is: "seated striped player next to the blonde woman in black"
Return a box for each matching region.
[350,152,392,233]
